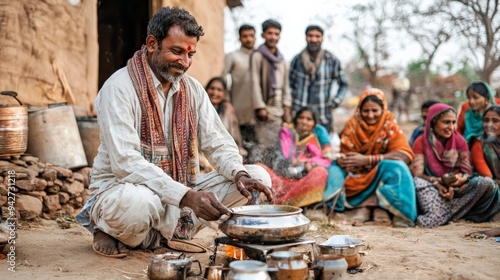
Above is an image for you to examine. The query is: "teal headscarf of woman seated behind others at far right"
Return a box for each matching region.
[464,81,495,143]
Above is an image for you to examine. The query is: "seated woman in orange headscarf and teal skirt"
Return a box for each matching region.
[323,88,417,227]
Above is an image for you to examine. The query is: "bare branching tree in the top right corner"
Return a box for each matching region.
[439,0,500,83]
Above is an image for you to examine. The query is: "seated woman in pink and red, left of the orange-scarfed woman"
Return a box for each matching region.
[257,108,331,207]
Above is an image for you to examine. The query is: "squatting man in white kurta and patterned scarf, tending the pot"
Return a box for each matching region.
[77,7,274,257]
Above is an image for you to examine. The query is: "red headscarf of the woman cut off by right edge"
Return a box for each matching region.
[481,105,500,182]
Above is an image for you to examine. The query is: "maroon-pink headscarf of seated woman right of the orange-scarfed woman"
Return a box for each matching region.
[423,103,472,176]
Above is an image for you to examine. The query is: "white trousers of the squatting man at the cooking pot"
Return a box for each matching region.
[90,165,271,249]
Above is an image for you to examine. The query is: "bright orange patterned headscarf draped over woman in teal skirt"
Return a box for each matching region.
[340,88,414,197]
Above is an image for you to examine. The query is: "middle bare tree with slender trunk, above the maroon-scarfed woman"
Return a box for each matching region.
[393,0,453,99]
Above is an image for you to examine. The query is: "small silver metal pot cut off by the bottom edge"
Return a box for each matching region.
[227,260,271,280]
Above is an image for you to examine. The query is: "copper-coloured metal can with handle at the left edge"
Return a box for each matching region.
[0,91,28,156]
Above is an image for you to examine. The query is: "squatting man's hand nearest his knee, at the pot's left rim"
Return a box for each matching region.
[179,190,231,221]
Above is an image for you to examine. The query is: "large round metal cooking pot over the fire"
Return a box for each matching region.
[219,205,310,243]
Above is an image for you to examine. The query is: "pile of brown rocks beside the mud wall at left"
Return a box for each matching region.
[0,154,91,220]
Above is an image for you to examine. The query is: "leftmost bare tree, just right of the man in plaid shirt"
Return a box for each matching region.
[345,0,392,86]
